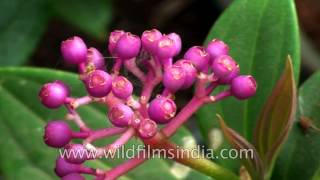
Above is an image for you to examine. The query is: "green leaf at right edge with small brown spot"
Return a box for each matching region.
[272,72,320,180]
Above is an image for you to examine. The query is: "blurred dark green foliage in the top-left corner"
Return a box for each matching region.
[0,0,111,66]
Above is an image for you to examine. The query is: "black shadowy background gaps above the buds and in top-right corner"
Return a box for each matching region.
[27,0,320,85]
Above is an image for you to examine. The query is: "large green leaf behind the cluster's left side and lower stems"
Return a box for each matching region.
[0,68,208,180]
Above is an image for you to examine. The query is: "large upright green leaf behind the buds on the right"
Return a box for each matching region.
[197,0,300,152]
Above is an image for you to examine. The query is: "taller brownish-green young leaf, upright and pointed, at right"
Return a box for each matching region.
[254,57,297,176]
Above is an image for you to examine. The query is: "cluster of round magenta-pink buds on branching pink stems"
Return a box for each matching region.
[39,29,257,180]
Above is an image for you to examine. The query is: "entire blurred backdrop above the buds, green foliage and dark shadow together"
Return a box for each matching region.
[0,0,320,81]
